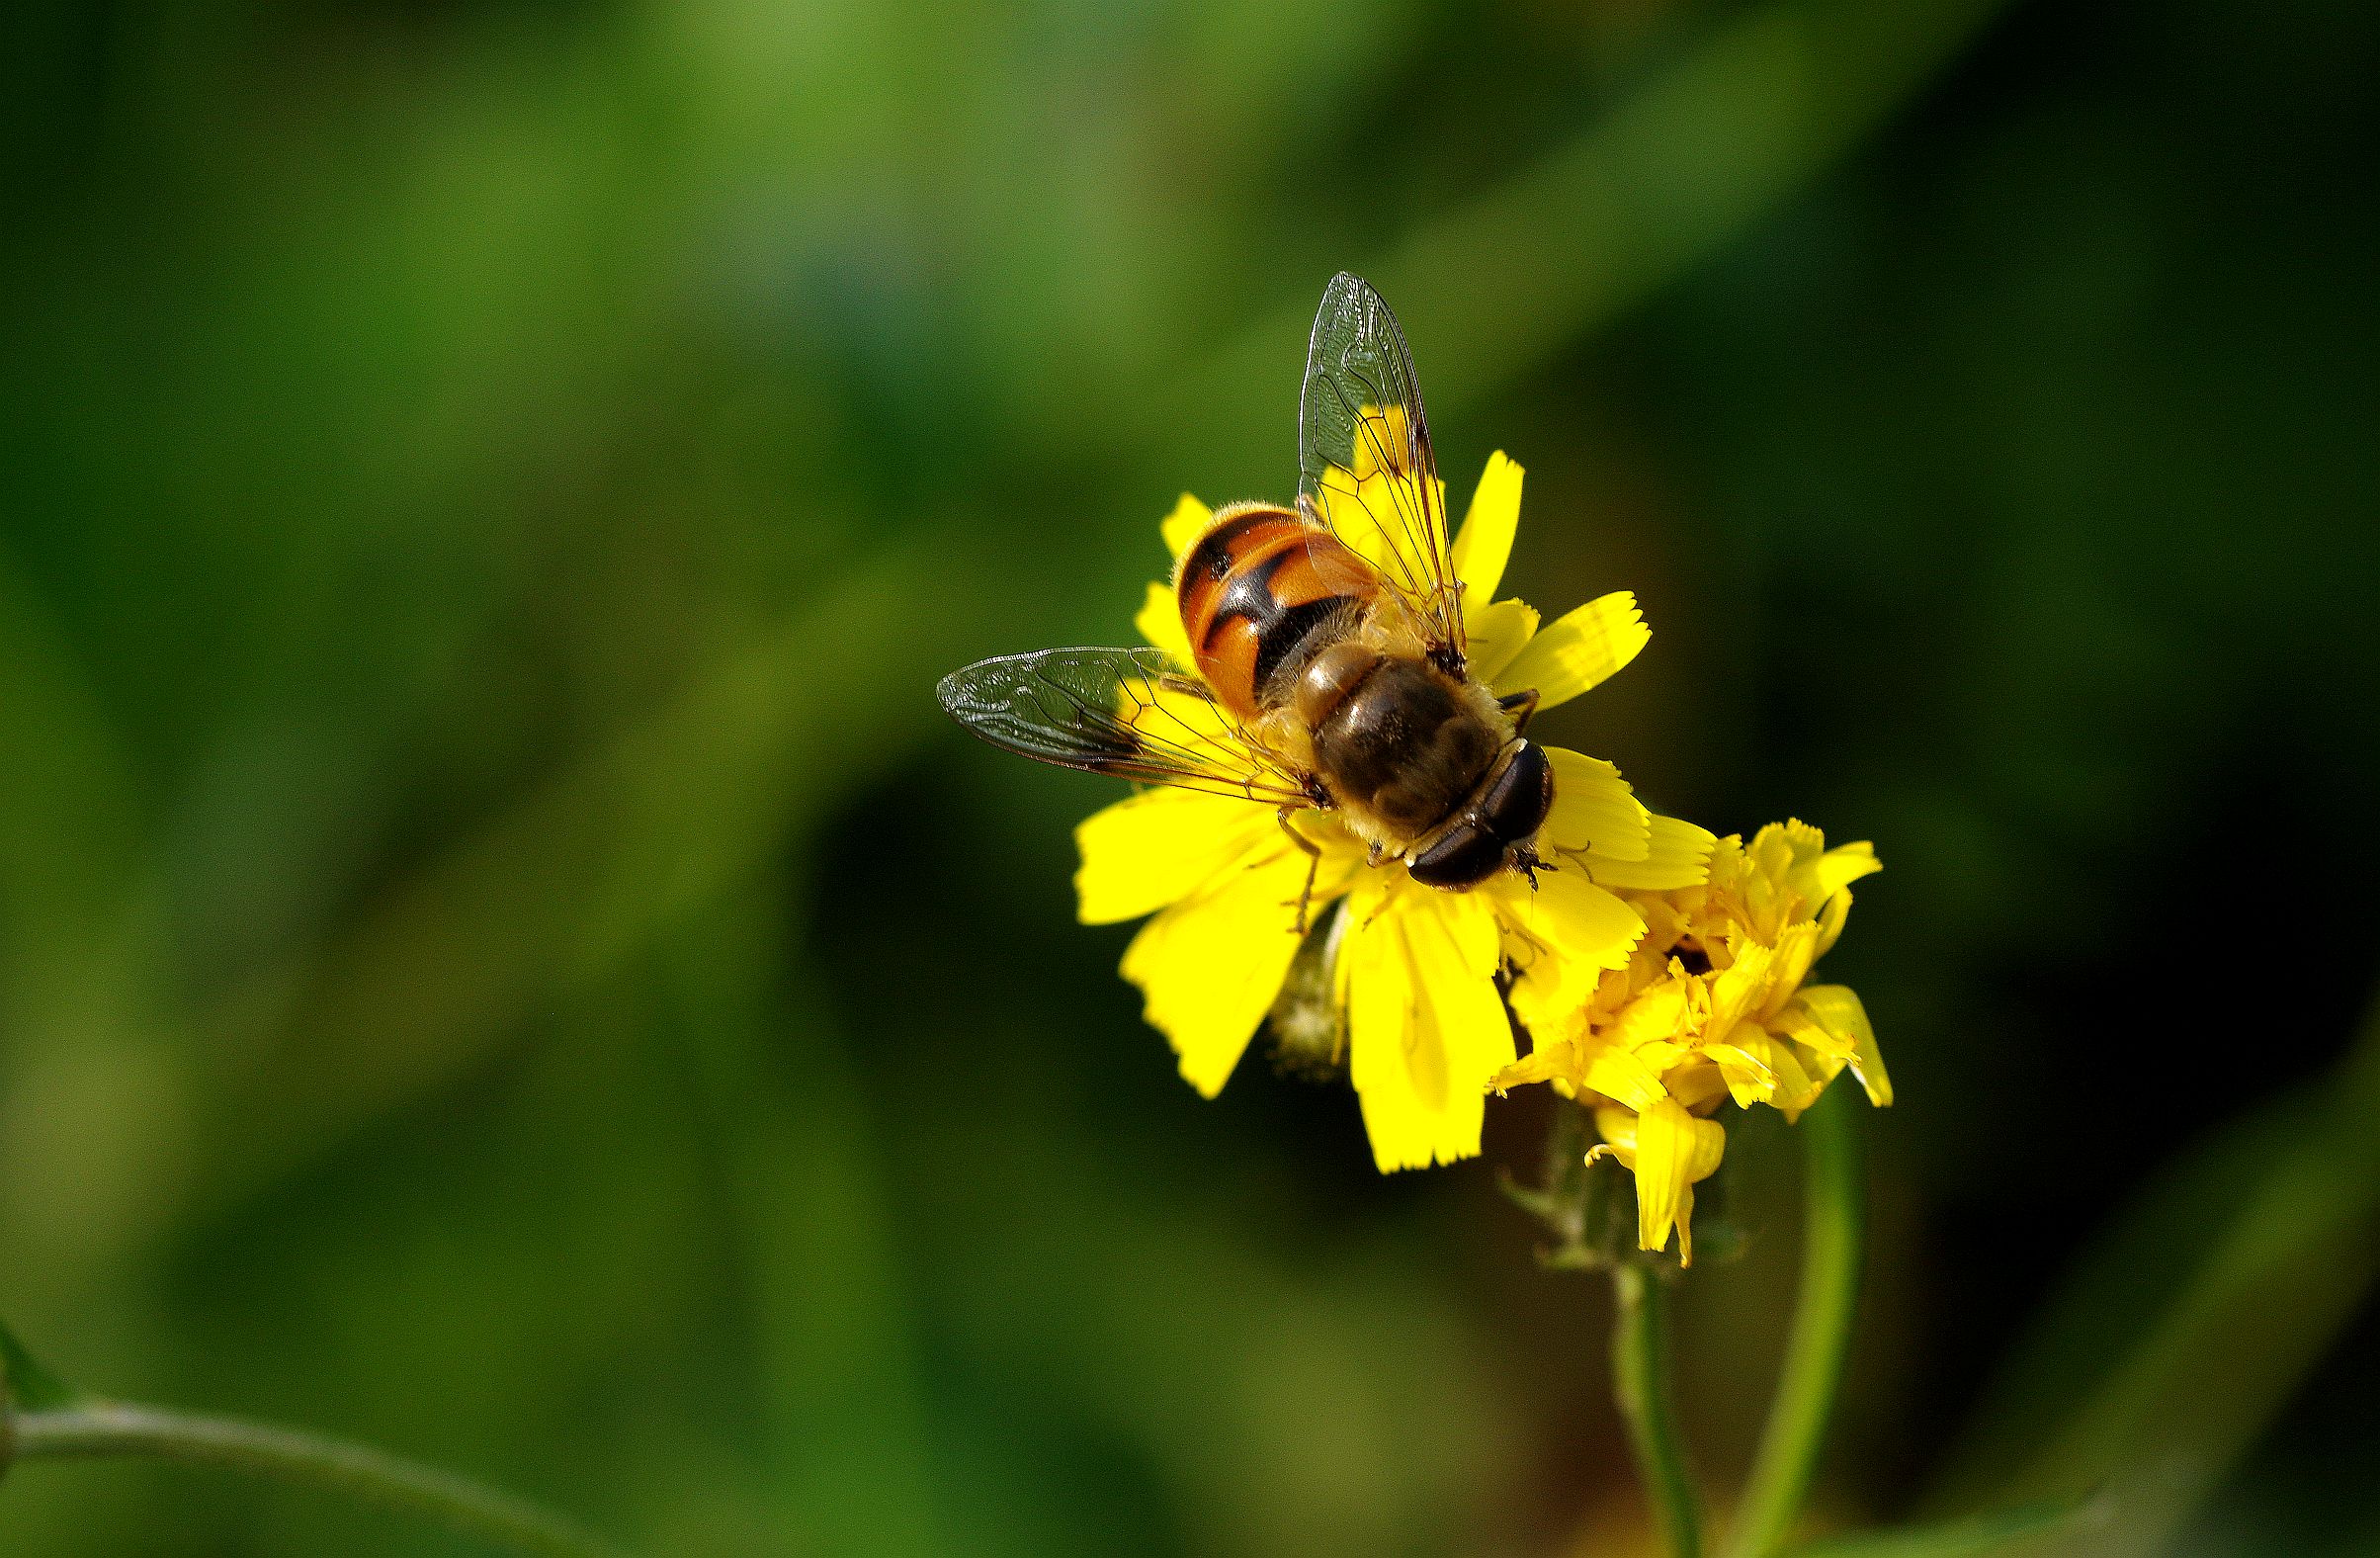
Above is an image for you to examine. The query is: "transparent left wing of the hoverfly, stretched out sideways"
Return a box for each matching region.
[935,648,1317,806]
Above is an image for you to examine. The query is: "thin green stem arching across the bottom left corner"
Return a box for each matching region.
[10,1401,614,1558]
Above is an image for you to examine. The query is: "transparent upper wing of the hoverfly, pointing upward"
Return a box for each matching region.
[1297,272,1464,672]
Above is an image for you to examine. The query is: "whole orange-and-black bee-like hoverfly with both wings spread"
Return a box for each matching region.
[938,272,1554,931]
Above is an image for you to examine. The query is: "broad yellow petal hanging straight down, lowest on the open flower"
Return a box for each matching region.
[1340,886,1513,1172]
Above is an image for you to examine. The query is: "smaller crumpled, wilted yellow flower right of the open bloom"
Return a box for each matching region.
[1494,822,1892,1262]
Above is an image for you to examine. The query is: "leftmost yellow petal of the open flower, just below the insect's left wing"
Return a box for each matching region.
[1073,791,1293,924]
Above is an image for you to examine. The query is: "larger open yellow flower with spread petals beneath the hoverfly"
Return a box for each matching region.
[1075,455,1711,1172]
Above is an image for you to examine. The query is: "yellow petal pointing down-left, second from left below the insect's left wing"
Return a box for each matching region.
[1124,843,1307,1098]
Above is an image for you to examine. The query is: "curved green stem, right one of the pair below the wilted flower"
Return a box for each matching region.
[1728,1086,1863,1558]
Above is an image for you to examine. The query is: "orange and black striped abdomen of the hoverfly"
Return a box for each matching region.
[1173,505,1381,717]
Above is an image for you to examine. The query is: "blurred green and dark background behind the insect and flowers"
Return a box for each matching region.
[0,0,2380,1558]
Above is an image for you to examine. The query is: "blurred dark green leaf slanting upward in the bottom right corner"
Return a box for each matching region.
[1942,1007,2380,1558]
